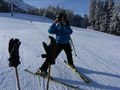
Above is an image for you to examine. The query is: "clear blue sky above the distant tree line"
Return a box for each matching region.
[24,0,89,15]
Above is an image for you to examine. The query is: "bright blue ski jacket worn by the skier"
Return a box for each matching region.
[48,23,73,44]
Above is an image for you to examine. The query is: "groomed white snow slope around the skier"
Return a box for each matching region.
[0,13,120,90]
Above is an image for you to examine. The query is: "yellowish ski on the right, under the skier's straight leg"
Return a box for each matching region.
[64,60,90,83]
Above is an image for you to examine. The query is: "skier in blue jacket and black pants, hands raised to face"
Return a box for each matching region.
[38,13,75,75]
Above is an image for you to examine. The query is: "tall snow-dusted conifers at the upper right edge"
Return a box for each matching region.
[89,0,120,35]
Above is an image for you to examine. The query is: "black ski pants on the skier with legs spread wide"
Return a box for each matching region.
[39,43,73,71]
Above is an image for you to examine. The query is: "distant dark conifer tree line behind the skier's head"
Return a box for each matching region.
[27,5,89,28]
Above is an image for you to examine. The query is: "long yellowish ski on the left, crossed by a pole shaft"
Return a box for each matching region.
[25,69,79,89]
